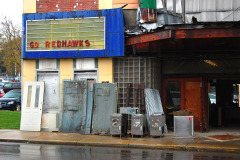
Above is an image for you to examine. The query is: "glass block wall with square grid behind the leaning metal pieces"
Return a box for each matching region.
[114,57,160,111]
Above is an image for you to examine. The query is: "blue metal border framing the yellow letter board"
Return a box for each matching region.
[22,8,124,59]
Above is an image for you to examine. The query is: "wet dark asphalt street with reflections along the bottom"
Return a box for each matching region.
[0,142,240,160]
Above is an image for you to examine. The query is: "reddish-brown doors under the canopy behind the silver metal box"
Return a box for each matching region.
[163,78,202,131]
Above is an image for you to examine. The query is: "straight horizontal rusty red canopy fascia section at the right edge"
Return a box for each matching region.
[174,29,240,39]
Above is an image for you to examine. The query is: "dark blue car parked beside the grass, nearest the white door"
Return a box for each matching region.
[0,89,21,111]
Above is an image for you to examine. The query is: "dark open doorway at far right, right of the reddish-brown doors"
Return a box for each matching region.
[209,77,240,130]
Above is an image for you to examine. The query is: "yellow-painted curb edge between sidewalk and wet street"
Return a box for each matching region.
[0,139,240,153]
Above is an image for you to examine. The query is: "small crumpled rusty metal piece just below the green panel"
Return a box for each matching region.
[140,8,157,23]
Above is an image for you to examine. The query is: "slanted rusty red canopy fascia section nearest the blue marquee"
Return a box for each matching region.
[126,30,172,45]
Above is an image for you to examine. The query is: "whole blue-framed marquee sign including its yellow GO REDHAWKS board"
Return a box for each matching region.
[22,9,124,59]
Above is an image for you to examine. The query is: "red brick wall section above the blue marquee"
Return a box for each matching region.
[36,0,98,13]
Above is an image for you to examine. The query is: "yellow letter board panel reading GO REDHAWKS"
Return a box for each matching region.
[26,17,105,51]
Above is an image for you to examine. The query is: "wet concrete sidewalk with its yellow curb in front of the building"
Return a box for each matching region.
[0,130,240,153]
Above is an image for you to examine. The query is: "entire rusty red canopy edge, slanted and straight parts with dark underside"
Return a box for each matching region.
[129,27,240,53]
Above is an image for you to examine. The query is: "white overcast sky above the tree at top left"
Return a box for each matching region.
[0,0,23,26]
